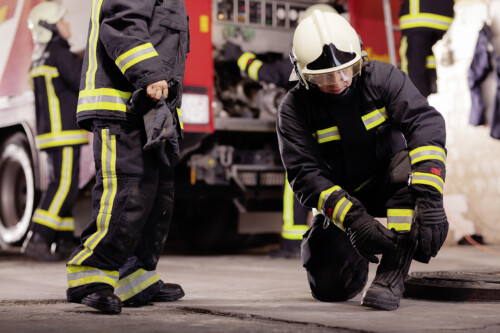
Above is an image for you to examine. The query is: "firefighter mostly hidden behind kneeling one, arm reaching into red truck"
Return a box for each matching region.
[223,4,337,258]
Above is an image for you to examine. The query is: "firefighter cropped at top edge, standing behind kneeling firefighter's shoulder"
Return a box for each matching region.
[399,0,453,97]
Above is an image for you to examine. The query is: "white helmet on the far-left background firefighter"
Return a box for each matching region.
[28,1,66,44]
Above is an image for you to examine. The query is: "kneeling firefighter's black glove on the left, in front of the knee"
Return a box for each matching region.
[344,196,397,264]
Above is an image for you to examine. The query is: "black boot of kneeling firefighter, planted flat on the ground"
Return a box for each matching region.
[361,233,417,311]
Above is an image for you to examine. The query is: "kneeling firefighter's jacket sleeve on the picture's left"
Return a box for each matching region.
[276,93,350,222]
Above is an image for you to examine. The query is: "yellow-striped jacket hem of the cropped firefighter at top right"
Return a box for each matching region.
[399,0,454,31]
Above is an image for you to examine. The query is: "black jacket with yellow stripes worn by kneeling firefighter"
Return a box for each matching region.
[277,61,446,213]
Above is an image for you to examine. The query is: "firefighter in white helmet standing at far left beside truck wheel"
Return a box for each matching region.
[21,2,88,261]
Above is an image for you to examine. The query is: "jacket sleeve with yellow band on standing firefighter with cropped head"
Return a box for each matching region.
[99,0,166,89]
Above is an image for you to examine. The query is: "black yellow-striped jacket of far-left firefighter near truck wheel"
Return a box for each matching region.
[30,36,88,149]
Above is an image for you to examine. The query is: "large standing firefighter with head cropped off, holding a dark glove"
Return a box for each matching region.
[67,0,189,313]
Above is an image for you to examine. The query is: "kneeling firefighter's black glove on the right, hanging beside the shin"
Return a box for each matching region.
[413,196,448,263]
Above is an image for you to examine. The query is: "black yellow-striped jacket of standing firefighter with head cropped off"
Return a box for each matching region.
[77,0,189,130]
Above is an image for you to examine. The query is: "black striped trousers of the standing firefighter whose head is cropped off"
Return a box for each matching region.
[67,120,174,303]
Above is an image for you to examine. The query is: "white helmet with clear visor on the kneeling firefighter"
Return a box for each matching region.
[290,10,363,89]
